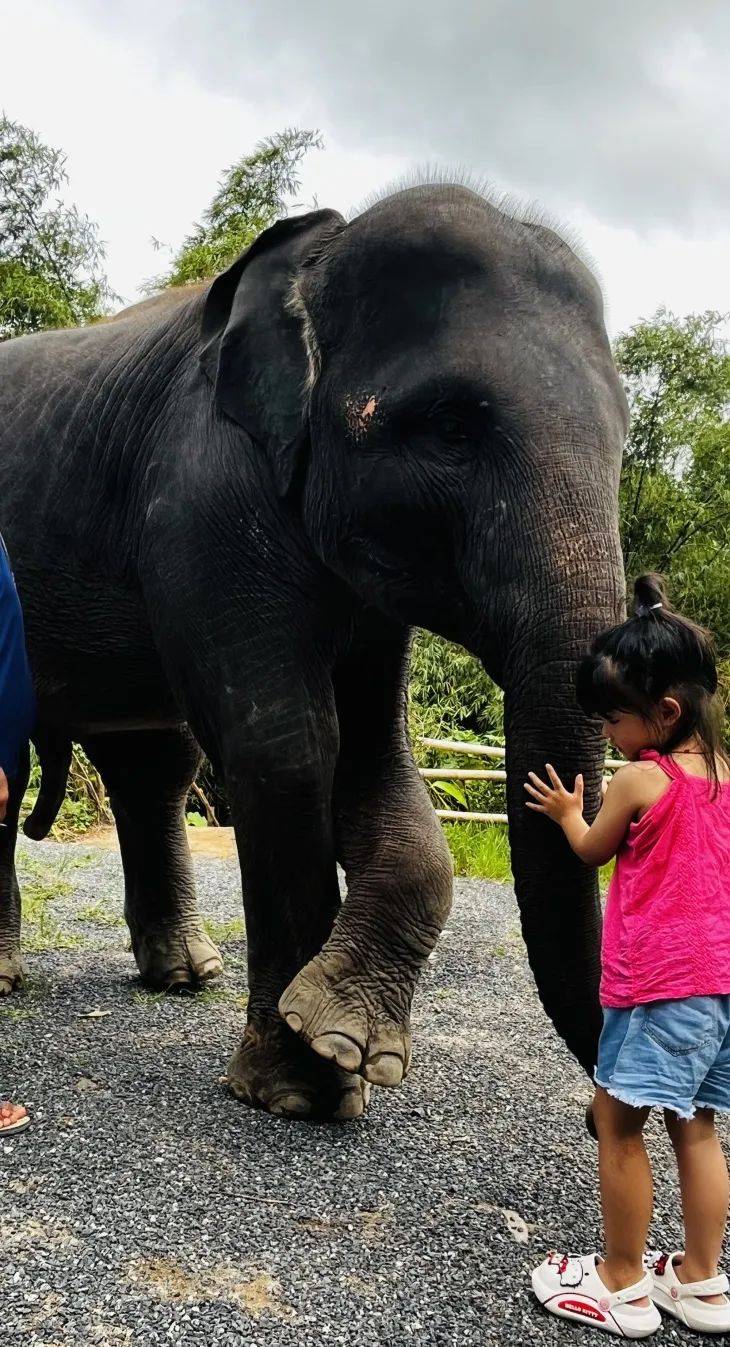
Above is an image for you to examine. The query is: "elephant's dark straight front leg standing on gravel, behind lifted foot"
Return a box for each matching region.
[224,678,369,1119]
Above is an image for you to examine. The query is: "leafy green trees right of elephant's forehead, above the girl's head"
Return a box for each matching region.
[616,308,730,659]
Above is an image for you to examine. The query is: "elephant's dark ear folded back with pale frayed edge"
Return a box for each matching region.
[201,210,345,494]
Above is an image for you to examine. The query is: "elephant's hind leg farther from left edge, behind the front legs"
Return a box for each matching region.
[82,726,222,990]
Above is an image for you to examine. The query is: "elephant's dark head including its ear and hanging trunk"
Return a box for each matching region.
[203,186,626,1070]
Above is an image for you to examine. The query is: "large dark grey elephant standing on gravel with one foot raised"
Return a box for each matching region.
[0,182,628,1118]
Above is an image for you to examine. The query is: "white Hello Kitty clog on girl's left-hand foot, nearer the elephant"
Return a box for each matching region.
[532,1253,661,1338]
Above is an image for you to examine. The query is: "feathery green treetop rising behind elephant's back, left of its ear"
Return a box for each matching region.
[155,128,322,290]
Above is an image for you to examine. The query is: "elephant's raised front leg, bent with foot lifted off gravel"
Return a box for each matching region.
[279,614,453,1086]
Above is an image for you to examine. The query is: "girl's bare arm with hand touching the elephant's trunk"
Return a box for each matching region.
[525,762,645,865]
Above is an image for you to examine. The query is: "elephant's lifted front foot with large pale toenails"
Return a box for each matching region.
[279,947,415,1086]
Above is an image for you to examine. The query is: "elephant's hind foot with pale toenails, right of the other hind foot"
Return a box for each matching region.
[129,921,224,991]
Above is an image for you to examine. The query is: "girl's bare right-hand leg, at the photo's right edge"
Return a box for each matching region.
[664,1109,730,1304]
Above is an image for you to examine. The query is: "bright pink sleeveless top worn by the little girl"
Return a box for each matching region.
[601,749,730,1008]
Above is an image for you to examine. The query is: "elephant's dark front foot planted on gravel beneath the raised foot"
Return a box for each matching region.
[226,1021,370,1121]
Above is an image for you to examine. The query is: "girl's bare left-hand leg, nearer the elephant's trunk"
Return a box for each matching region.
[593,1086,653,1305]
